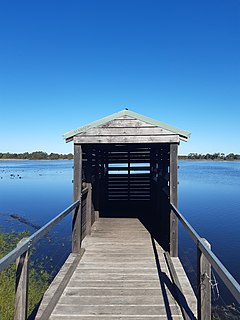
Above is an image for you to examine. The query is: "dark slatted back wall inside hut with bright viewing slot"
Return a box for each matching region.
[100,145,152,217]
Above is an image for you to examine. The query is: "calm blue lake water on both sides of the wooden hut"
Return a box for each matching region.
[0,161,240,304]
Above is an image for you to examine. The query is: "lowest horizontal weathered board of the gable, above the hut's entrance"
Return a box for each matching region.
[74,134,180,144]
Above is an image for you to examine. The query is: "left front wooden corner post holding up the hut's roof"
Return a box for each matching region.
[72,144,82,253]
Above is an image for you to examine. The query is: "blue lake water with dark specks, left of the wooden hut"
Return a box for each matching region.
[0,160,73,232]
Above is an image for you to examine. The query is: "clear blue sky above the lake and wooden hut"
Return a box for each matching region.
[0,0,240,154]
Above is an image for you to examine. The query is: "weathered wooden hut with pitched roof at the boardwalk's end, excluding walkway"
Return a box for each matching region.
[64,109,190,257]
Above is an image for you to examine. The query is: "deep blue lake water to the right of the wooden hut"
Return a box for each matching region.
[179,161,240,303]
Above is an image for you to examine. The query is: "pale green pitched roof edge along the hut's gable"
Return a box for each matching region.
[64,109,191,142]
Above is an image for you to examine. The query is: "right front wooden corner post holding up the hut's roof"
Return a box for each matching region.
[170,144,178,257]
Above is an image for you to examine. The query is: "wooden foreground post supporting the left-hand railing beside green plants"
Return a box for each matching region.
[14,238,29,320]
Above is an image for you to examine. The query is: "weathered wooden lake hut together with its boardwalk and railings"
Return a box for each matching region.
[0,109,240,320]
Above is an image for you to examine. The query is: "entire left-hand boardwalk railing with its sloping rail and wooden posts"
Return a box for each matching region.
[0,186,92,320]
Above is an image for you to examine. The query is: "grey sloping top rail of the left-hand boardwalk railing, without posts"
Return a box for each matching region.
[0,200,80,272]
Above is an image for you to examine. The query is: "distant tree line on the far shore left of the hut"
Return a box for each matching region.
[0,151,73,160]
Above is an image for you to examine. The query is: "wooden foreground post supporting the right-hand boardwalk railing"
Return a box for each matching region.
[197,239,211,320]
